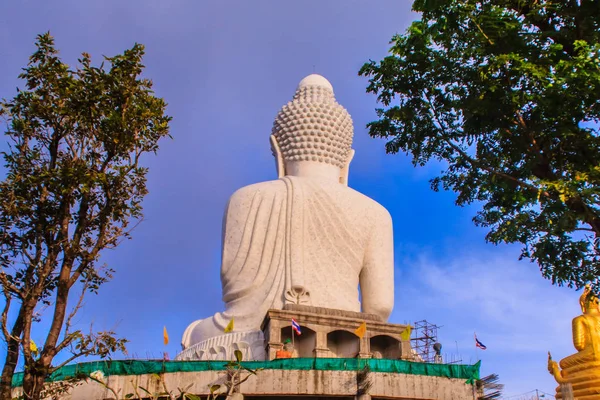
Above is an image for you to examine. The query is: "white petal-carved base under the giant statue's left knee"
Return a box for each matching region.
[175,331,266,361]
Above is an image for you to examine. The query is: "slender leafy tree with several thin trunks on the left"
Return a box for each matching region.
[0,33,171,399]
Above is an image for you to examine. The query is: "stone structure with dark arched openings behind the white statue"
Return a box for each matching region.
[262,304,413,360]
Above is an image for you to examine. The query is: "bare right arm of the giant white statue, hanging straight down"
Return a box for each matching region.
[360,207,394,321]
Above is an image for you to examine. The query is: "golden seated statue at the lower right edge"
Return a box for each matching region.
[548,286,600,400]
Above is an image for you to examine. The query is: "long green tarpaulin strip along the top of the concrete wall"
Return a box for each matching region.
[13,358,480,386]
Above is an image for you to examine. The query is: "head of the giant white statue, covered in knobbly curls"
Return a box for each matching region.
[271,74,354,184]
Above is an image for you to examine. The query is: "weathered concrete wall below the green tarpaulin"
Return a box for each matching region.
[13,370,474,400]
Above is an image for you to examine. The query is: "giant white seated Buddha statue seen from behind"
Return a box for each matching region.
[182,74,394,349]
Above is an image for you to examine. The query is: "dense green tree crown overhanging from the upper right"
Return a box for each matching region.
[359,0,600,292]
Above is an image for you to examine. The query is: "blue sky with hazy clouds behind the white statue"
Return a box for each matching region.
[0,0,579,395]
